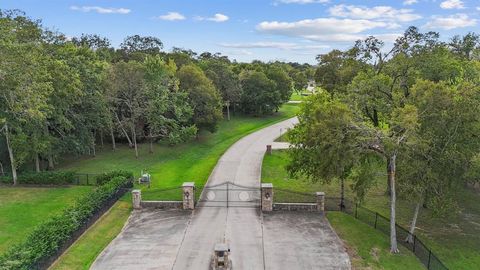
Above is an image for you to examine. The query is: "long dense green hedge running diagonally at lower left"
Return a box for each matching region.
[0,172,133,270]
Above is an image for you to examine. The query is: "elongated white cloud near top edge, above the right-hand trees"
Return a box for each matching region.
[329,4,422,22]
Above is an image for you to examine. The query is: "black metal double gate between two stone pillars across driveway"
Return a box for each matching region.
[196,182,261,208]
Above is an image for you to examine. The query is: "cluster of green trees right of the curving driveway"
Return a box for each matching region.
[288,27,480,253]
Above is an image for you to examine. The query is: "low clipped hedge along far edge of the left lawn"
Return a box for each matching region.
[0,171,75,185]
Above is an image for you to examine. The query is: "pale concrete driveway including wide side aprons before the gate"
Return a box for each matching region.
[92,118,350,270]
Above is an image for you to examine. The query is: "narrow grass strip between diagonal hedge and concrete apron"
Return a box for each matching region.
[49,196,132,270]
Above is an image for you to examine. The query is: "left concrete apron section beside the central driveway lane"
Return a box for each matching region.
[90,209,191,270]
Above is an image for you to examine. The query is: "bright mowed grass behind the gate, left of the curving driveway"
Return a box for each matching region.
[60,104,299,200]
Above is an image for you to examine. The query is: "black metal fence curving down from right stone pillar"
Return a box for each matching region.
[325,197,448,270]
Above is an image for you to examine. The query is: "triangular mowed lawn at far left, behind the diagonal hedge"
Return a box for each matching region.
[0,186,92,254]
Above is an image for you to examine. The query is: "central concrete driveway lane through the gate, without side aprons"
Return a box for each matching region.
[173,118,298,270]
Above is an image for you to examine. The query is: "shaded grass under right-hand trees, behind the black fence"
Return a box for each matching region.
[262,151,480,269]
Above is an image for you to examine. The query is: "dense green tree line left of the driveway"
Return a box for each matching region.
[0,10,312,183]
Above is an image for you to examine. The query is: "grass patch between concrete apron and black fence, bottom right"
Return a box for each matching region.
[327,212,425,270]
